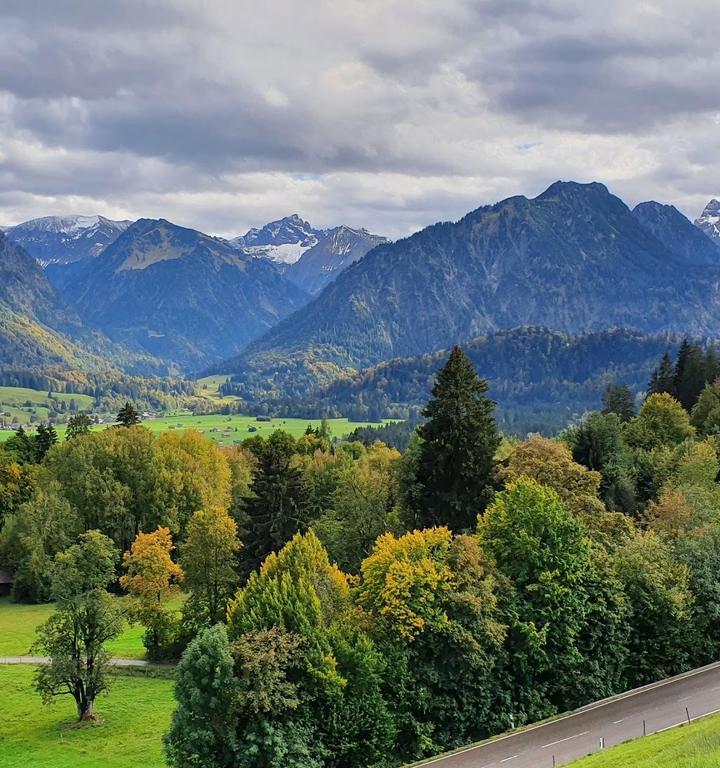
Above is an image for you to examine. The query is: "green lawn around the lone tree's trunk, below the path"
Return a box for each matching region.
[0,665,174,768]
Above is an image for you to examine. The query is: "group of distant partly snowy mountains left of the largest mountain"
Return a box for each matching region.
[6,215,384,373]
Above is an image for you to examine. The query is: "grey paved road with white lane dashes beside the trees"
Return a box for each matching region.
[414,663,720,768]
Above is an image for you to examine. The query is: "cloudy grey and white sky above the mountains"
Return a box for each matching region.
[0,0,720,237]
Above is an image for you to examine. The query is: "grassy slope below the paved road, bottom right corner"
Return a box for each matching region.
[570,715,720,768]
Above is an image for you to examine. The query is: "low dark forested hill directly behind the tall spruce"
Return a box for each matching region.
[221,328,681,435]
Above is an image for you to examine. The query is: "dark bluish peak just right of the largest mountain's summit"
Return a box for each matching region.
[633,201,720,266]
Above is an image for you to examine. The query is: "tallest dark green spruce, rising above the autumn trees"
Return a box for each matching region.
[417,346,500,533]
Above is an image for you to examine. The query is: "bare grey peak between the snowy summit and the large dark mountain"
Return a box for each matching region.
[285,226,387,294]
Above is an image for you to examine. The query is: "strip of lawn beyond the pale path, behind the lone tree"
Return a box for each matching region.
[0,597,145,660]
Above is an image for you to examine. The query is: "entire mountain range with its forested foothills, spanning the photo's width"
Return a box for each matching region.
[0,181,720,432]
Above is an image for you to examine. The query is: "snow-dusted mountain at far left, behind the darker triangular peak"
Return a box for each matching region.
[6,216,132,266]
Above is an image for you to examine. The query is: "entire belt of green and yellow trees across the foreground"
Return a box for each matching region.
[7,348,720,768]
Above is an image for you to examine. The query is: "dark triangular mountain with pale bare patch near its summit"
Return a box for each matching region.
[57,219,307,371]
